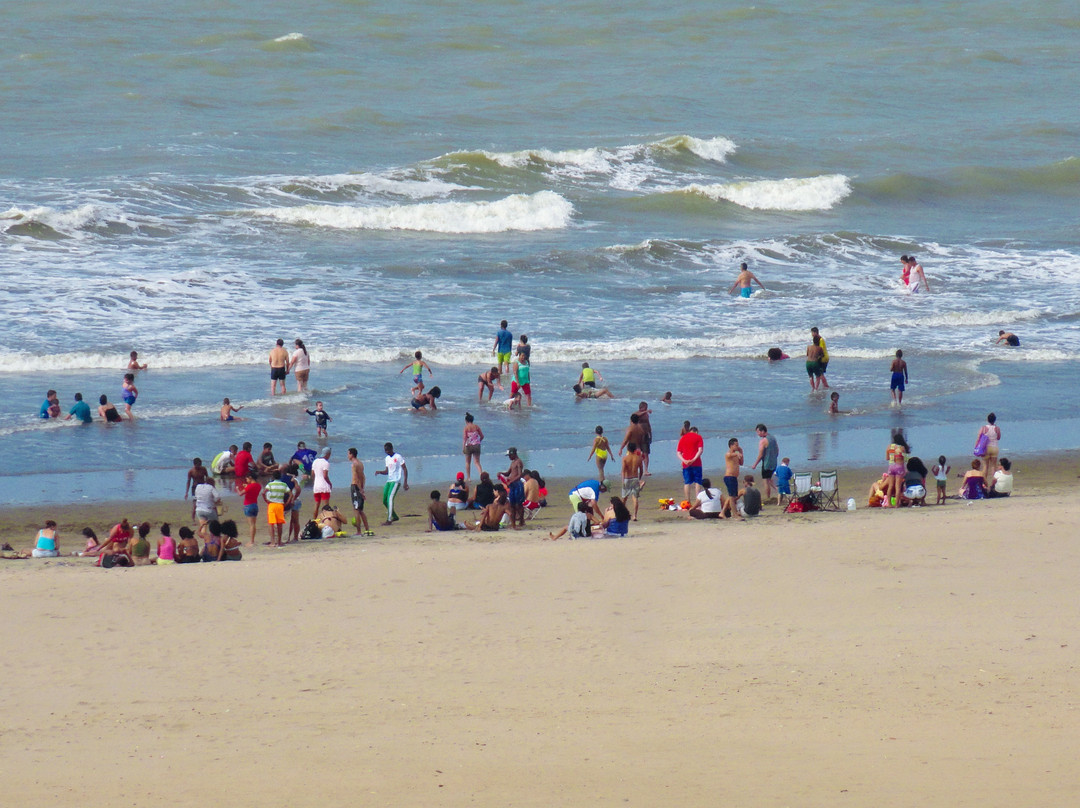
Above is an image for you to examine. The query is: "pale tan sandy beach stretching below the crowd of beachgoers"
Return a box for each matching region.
[0,456,1080,808]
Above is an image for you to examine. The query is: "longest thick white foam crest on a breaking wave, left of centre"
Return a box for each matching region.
[249,191,573,233]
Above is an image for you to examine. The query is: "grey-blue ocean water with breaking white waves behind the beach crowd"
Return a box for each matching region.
[0,0,1080,502]
